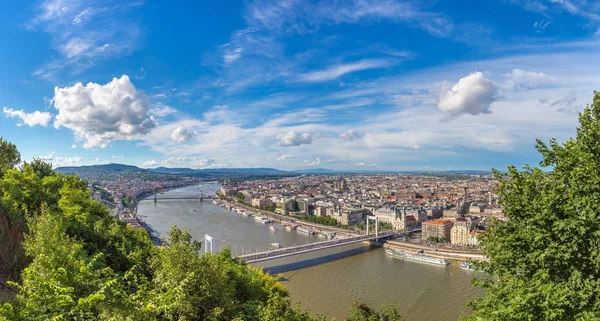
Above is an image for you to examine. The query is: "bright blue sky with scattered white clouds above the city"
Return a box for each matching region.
[0,0,600,170]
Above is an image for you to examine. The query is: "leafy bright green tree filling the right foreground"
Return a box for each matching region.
[465,92,600,320]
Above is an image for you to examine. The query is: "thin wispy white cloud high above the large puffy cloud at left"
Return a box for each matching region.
[25,0,142,80]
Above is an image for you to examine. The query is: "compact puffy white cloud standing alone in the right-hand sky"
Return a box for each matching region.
[438,72,498,116]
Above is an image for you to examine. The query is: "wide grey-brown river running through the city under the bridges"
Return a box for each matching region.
[138,183,483,321]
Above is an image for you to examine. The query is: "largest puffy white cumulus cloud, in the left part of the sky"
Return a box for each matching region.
[52,75,156,148]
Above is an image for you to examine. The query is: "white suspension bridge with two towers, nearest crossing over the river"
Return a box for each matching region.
[201,216,398,263]
